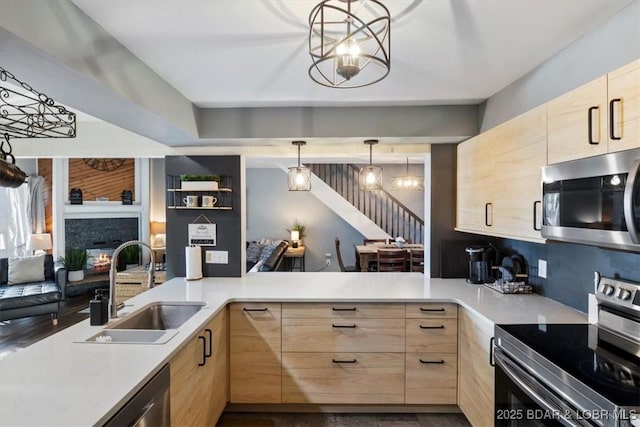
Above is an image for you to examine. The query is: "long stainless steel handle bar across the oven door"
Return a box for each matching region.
[493,348,593,427]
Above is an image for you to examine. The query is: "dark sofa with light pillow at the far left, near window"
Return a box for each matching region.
[0,254,67,325]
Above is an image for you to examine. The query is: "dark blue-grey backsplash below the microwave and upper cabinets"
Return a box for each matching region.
[501,239,640,313]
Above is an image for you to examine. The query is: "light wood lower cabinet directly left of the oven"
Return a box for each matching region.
[458,307,495,427]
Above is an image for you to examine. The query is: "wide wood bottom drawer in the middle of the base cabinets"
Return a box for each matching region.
[282,353,404,404]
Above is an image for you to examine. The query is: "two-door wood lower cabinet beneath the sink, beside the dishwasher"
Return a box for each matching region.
[169,310,228,426]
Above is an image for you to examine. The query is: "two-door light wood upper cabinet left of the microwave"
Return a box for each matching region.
[456,106,547,242]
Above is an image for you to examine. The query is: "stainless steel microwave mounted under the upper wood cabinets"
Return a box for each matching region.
[541,148,640,252]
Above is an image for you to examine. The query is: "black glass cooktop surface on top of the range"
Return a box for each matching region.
[498,324,640,407]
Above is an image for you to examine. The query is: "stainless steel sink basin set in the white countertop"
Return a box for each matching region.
[109,302,206,331]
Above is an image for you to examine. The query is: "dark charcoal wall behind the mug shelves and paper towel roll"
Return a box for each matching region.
[165,156,245,278]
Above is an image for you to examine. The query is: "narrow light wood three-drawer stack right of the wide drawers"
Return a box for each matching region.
[405,303,458,404]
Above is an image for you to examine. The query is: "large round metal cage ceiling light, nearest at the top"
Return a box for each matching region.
[309,0,391,88]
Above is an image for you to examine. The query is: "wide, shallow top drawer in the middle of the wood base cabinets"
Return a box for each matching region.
[282,303,404,319]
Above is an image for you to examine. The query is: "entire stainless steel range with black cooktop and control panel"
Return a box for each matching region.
[493,275,640,427]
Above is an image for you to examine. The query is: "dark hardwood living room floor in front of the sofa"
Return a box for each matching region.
[0,294,91,359]
